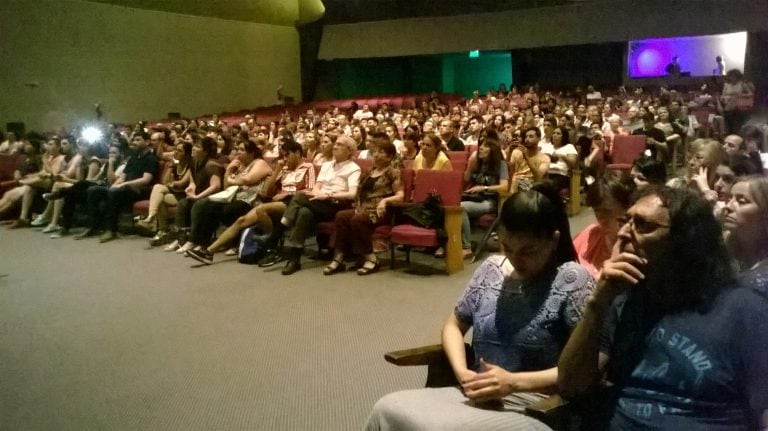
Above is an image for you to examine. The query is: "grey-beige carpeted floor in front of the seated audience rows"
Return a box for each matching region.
[0,210,592,430]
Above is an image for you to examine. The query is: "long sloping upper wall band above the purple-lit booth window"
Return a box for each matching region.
[319,0,768,60]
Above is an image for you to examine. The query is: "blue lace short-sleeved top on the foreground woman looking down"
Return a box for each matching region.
[455,255,595,371]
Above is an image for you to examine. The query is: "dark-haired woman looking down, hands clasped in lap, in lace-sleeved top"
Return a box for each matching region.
[367,184,594,430]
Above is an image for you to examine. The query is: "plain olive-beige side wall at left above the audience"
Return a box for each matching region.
[0,0,301,130]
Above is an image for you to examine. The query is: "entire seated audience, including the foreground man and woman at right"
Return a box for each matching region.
[0,80,768,429]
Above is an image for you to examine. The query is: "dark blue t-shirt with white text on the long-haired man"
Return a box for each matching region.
[601,288,768,431]
